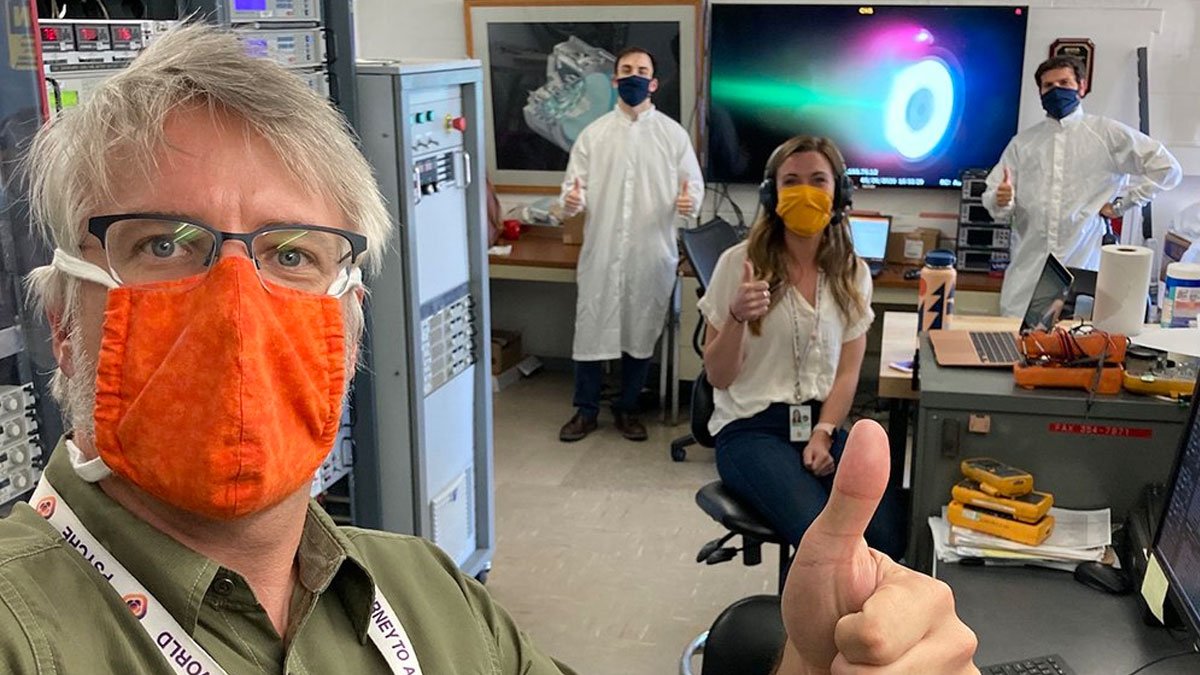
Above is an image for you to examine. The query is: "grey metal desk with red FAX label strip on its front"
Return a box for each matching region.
[908,336,1188,569]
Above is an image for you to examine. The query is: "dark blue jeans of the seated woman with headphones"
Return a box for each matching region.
[716,404,907,560]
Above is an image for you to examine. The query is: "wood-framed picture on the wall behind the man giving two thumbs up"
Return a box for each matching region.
[463,0,703,193]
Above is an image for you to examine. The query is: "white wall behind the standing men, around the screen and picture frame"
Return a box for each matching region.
[355,0,1200,233]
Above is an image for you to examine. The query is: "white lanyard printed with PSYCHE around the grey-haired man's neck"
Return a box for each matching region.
[30,474,421,675]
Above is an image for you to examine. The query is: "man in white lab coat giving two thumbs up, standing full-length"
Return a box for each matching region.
[558,47,704,441]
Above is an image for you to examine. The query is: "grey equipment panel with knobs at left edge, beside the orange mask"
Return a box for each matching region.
[0,384,42,503]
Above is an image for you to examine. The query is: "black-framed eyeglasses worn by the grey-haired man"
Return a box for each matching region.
[88,213,367,295]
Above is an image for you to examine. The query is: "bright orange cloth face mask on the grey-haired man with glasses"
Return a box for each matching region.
[95,257,346,519]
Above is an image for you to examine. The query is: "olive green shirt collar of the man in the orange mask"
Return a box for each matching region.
[46,442,374,641]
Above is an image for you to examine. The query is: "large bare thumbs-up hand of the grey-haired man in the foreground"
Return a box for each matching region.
[779,420,979,675]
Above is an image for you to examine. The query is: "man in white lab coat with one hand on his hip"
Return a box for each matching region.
[983,56,1182,316]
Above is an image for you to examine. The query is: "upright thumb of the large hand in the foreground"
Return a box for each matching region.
[804,419,890,557]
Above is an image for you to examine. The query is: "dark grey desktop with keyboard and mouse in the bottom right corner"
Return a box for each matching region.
[935,563,1200,675]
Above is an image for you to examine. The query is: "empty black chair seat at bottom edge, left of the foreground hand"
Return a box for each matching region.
[679,596,787,675]
